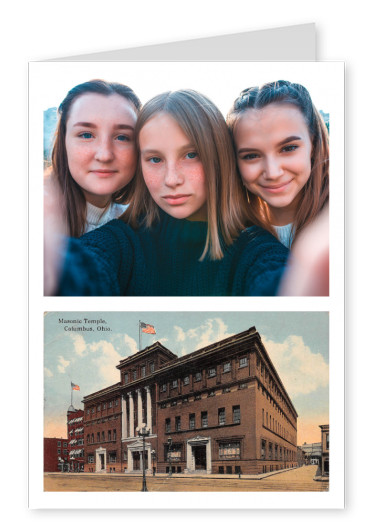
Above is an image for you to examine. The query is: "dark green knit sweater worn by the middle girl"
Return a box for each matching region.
[58,213,288,296]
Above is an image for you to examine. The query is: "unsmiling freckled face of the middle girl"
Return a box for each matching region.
[139,112,207,221]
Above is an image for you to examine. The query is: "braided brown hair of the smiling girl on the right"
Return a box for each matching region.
[227,80,329,245]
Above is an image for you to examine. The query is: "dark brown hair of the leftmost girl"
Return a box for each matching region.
[51,79,141,237]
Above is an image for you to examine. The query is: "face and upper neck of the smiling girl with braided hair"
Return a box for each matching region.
[234,103,312,225]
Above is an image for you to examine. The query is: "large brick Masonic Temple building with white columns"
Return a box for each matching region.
[83,327,297,474]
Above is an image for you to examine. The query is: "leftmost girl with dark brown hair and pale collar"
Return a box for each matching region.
[51,79,141,237]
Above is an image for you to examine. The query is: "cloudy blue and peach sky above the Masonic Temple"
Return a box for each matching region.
[44,312,329,444]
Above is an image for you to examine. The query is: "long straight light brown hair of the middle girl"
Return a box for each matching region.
[121,89,254,260]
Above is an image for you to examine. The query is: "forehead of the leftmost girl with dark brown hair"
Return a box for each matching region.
[67,93,137,124]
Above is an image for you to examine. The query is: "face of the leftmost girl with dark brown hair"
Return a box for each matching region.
[65,93,137,207]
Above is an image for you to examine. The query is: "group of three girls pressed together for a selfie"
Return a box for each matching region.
[44,79,329,296]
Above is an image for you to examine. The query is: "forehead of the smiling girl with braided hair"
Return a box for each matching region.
[234,103,308,136]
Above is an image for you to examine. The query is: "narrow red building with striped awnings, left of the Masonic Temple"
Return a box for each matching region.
[67,405,85,472]
